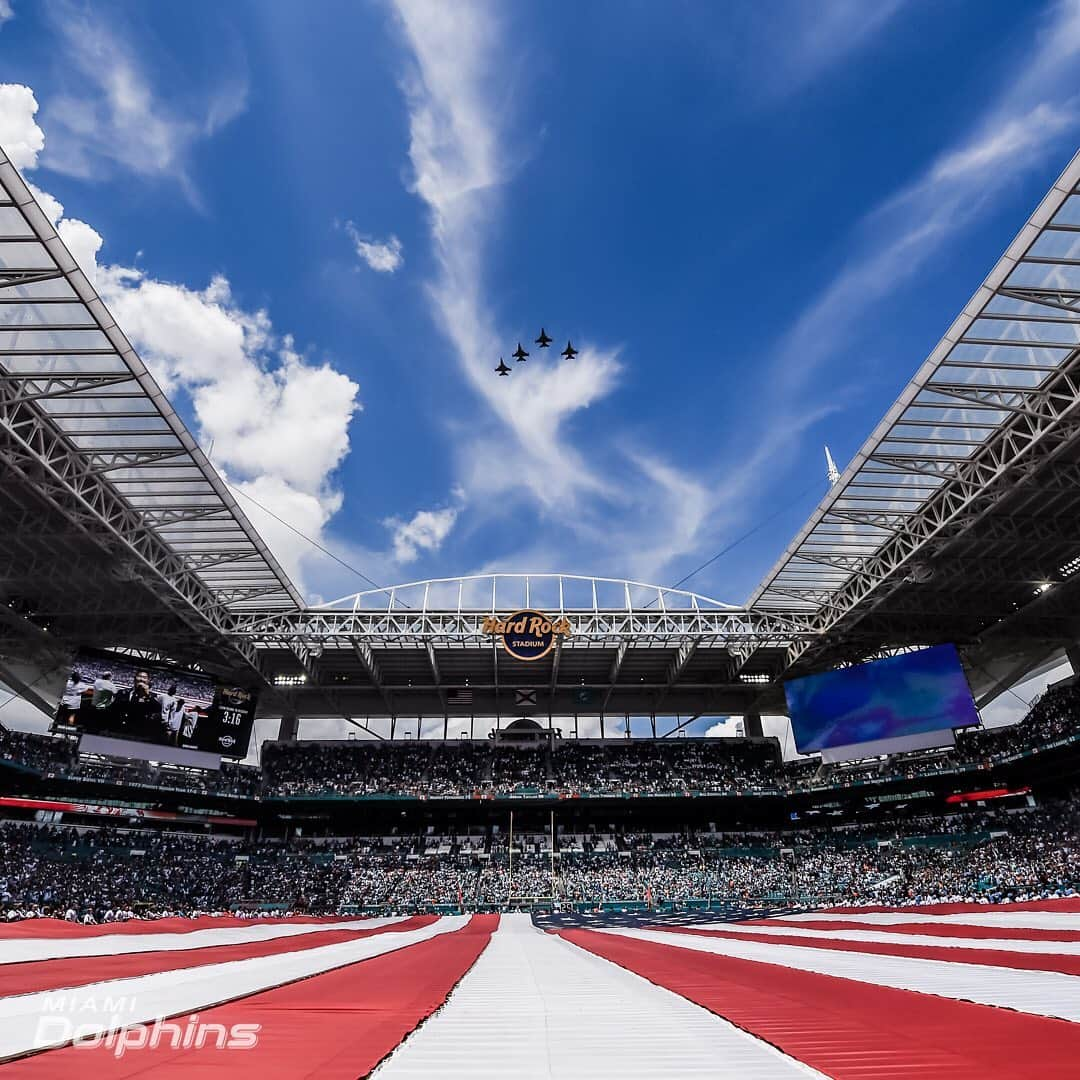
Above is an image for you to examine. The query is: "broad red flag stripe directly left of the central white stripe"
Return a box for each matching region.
[4,915,498,1080]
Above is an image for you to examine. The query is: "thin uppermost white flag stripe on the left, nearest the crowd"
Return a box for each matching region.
[0,916,404,964]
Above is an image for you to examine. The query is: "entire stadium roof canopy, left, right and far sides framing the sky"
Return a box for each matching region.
[0,143,1080,717]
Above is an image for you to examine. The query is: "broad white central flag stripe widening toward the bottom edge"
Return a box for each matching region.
[374,915,822,1080]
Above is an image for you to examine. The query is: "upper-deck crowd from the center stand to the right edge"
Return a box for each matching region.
[257,685,1080,797]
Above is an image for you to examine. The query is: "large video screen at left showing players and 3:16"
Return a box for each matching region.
[53,649,256,757]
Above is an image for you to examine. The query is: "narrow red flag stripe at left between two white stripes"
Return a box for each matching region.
[0,915,437,998]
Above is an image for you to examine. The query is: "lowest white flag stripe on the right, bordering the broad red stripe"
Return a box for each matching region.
[596,927,1080,1021]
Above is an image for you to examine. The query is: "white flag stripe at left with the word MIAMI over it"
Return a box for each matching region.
[0,916,469,1061]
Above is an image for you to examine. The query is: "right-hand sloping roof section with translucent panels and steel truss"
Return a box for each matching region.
[750,143,1080,660]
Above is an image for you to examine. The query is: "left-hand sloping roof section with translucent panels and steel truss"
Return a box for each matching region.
[0,140,300,669]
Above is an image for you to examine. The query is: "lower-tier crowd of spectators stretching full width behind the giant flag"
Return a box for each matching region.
[0,801,1080,921]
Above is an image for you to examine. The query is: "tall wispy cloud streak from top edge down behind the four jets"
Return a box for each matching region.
[396,0,618,502]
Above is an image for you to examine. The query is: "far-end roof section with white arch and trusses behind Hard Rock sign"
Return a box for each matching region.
[227,573,810,717]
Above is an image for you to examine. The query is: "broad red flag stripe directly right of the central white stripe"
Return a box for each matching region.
[562,930,1080,1080]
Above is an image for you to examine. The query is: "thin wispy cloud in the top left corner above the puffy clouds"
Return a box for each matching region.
[43,0,247,202]
